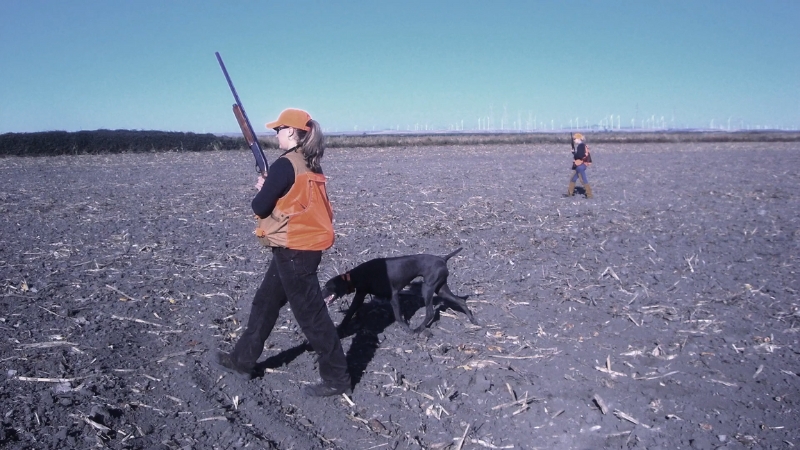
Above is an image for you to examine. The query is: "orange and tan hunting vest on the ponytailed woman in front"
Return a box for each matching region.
[255,148,334,250]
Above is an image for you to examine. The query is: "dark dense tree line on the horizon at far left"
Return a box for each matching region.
[0,130,260,156]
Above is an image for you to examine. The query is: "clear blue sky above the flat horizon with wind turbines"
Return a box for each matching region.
[0,0,800,133]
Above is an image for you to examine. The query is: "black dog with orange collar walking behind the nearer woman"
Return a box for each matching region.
[322,248,478,333]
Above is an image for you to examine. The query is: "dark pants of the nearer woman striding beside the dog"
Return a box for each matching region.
[232,248,350,386]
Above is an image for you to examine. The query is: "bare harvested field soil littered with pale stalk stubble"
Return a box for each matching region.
[0,142,800,450]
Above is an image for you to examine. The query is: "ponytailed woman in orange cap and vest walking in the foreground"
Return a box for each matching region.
[217,109,351,397]
